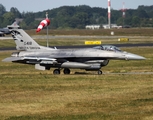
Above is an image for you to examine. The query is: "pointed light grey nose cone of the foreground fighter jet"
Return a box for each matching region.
[125,53,146,60]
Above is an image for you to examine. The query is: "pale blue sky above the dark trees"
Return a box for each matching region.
[0,0,153,12]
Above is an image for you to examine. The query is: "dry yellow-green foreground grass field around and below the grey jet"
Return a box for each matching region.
[0,47,153,120]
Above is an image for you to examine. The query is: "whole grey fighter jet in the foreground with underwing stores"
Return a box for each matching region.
[3,26,145,75]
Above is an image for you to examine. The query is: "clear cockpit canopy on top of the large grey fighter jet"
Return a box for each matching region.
[93,45,122,52]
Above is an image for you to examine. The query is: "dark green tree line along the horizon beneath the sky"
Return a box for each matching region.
[0,4,153,29]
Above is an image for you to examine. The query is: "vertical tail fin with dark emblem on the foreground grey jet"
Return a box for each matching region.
[7,23,45,51]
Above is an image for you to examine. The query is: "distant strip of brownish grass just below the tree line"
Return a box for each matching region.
[26,28,153,36]
